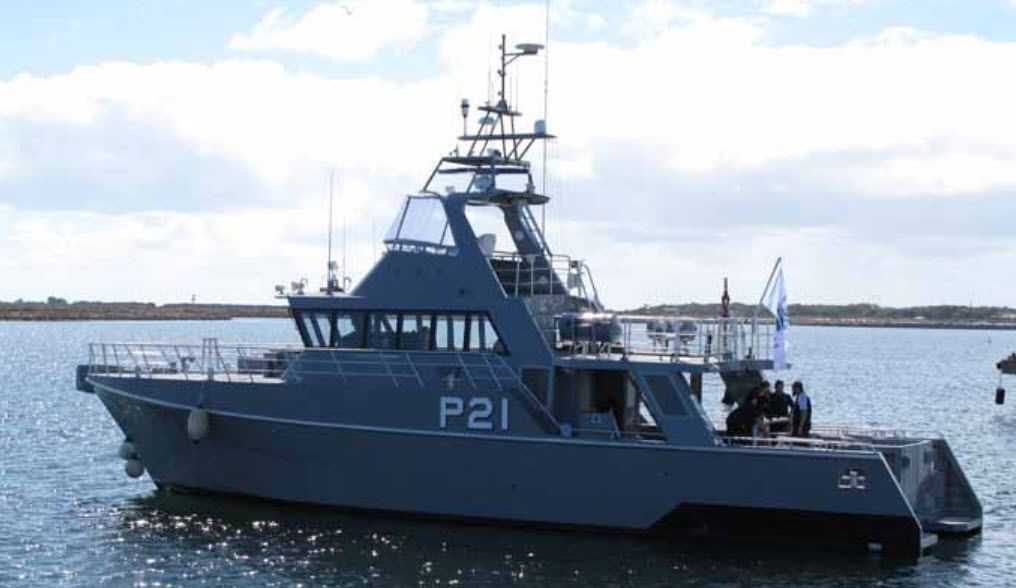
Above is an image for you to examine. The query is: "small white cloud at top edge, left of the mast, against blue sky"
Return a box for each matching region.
[230,0,430,61]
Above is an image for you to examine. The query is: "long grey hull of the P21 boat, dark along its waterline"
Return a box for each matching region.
[93,378,927,554]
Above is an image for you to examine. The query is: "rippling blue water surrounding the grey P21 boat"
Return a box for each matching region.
[0,320,1016,587]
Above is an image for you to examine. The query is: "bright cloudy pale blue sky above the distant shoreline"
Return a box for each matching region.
[0,0,1016,308]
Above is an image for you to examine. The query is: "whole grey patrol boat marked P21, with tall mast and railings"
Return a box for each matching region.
[77,37,981,556]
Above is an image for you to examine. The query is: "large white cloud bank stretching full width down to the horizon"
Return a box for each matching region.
[0,3,1016,306]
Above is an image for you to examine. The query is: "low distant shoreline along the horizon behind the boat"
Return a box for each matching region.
[0,302,1016,330]
